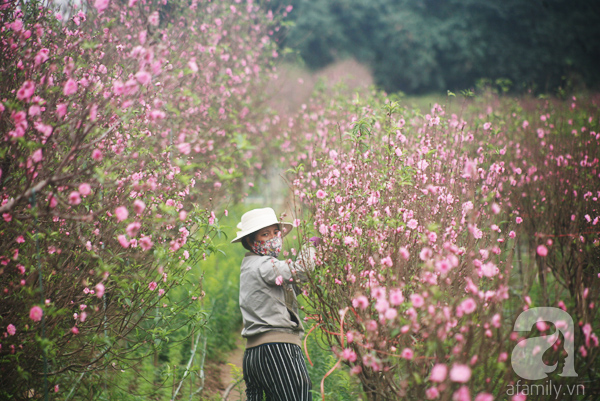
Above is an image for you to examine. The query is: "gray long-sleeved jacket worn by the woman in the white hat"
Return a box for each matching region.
[240,247,314,347]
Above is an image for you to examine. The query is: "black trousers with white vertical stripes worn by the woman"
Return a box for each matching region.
[243,343,312,401]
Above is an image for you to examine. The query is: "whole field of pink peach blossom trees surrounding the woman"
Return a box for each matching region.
[0,0,600,401]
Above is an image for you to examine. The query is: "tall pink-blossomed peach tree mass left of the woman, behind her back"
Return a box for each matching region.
[0,0,284,399]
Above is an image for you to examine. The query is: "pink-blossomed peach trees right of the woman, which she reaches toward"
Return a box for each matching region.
[282,93,600,401]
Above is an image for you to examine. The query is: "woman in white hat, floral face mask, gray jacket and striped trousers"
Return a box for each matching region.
[231,208,319,401]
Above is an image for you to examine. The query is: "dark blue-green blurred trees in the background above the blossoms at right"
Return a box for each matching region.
[267,0,600,93]
